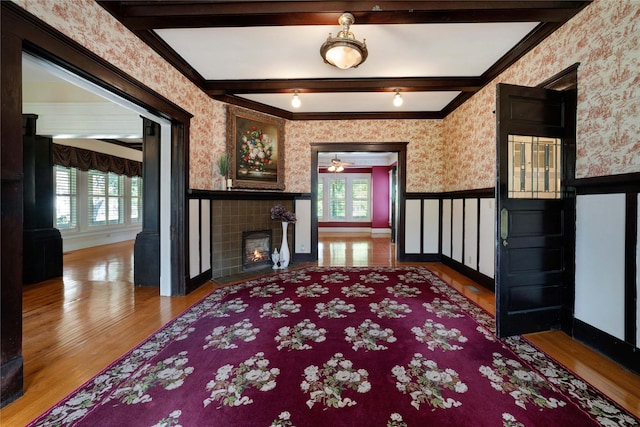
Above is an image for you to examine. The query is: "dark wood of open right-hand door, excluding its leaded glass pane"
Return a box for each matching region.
[496,68,576,337]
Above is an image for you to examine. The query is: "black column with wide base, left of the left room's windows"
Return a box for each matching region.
[22,114,62,283]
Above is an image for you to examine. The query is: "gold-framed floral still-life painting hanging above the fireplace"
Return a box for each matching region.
[227,105,284,190]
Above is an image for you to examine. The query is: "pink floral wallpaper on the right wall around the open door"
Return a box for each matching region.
[443,0,640,191]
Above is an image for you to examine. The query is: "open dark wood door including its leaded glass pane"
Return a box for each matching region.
[496,84,574,337]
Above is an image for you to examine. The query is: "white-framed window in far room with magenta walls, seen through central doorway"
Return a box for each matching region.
[317,173,371,222]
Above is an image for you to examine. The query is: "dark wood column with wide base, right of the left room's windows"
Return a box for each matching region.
[133,118,160,287]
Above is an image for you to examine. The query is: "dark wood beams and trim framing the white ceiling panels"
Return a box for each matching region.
[98,0,591,120]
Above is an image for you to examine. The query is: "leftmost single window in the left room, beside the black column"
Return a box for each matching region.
[54,166,78,230]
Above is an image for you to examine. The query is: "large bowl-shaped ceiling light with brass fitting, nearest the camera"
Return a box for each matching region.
[320,12,369,70]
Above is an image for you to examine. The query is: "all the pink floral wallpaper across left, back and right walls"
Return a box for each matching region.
[13,0,640,192]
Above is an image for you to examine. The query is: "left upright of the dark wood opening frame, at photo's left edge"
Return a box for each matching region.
[0,29,23,407]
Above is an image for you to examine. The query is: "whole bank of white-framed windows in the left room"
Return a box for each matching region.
[54,166,143,233]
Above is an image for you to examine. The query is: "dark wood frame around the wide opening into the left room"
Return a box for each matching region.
[0,1,192,406]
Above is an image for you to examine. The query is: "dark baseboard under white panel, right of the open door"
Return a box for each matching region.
[573,319,640,374]
